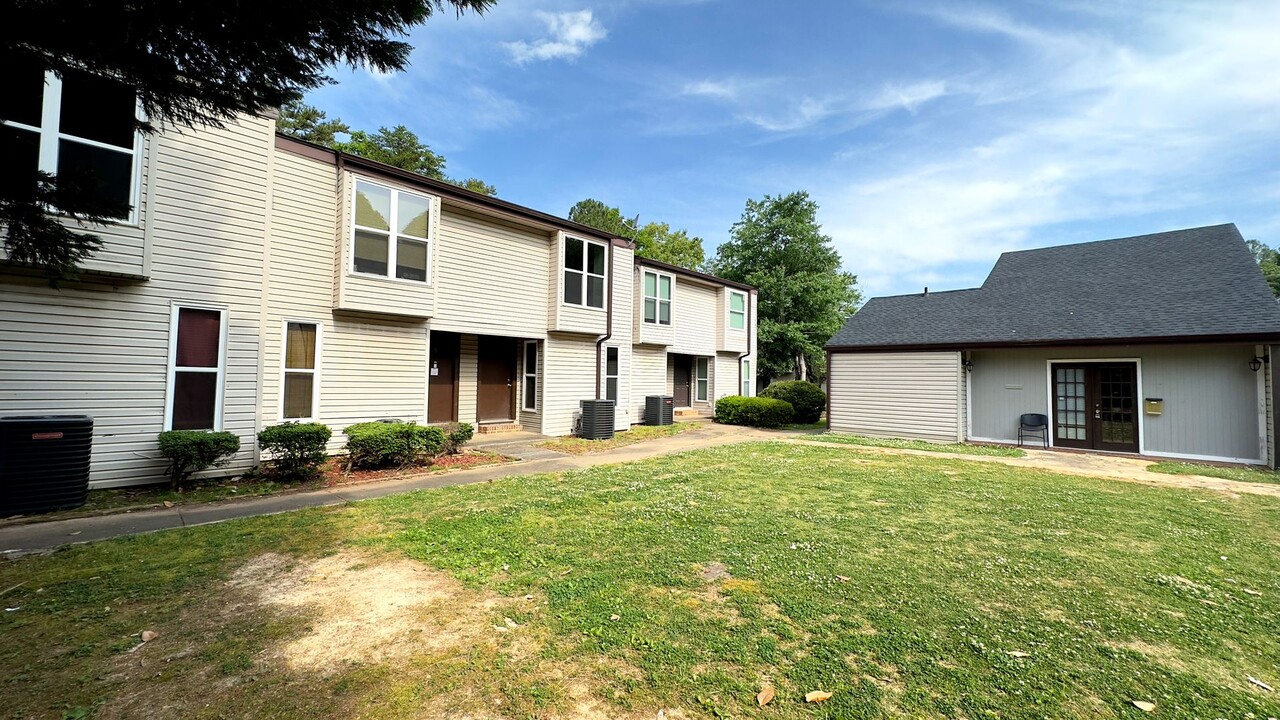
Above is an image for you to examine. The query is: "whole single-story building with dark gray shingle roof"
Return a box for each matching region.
[827,224,1280,468]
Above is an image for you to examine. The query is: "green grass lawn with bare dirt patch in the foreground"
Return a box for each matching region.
[0,443,1280,719]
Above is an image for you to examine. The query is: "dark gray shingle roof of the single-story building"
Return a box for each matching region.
[827,224,1280,348]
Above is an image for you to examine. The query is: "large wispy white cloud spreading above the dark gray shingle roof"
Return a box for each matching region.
[819,4,1280,292]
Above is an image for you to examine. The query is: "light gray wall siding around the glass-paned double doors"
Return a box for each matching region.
[970,345,1267,462]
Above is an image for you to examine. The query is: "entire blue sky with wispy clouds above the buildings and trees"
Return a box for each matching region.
[307,0,1280,296]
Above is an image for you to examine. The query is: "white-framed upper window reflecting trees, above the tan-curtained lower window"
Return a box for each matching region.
[351,181,431,283]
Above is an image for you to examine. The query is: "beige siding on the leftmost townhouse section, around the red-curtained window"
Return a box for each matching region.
[0,118,274,487]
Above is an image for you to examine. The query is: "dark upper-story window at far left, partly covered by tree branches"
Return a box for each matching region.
[0,68,141,222]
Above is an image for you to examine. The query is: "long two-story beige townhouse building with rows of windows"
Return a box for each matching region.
[0,76,755,487]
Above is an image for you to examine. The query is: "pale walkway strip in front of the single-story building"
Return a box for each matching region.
[787,438,1280,497]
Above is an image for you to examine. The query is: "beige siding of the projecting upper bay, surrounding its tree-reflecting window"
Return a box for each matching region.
[333,173,440,318]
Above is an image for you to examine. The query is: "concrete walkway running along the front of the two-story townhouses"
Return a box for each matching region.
[0,425,778,553]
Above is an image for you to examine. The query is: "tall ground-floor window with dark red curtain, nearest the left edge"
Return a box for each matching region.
[164,305,227,430]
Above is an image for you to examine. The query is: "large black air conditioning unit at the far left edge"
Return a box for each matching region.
[0,415,93,518]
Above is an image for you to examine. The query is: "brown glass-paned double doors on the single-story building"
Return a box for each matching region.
[1052,363,1138,452]
